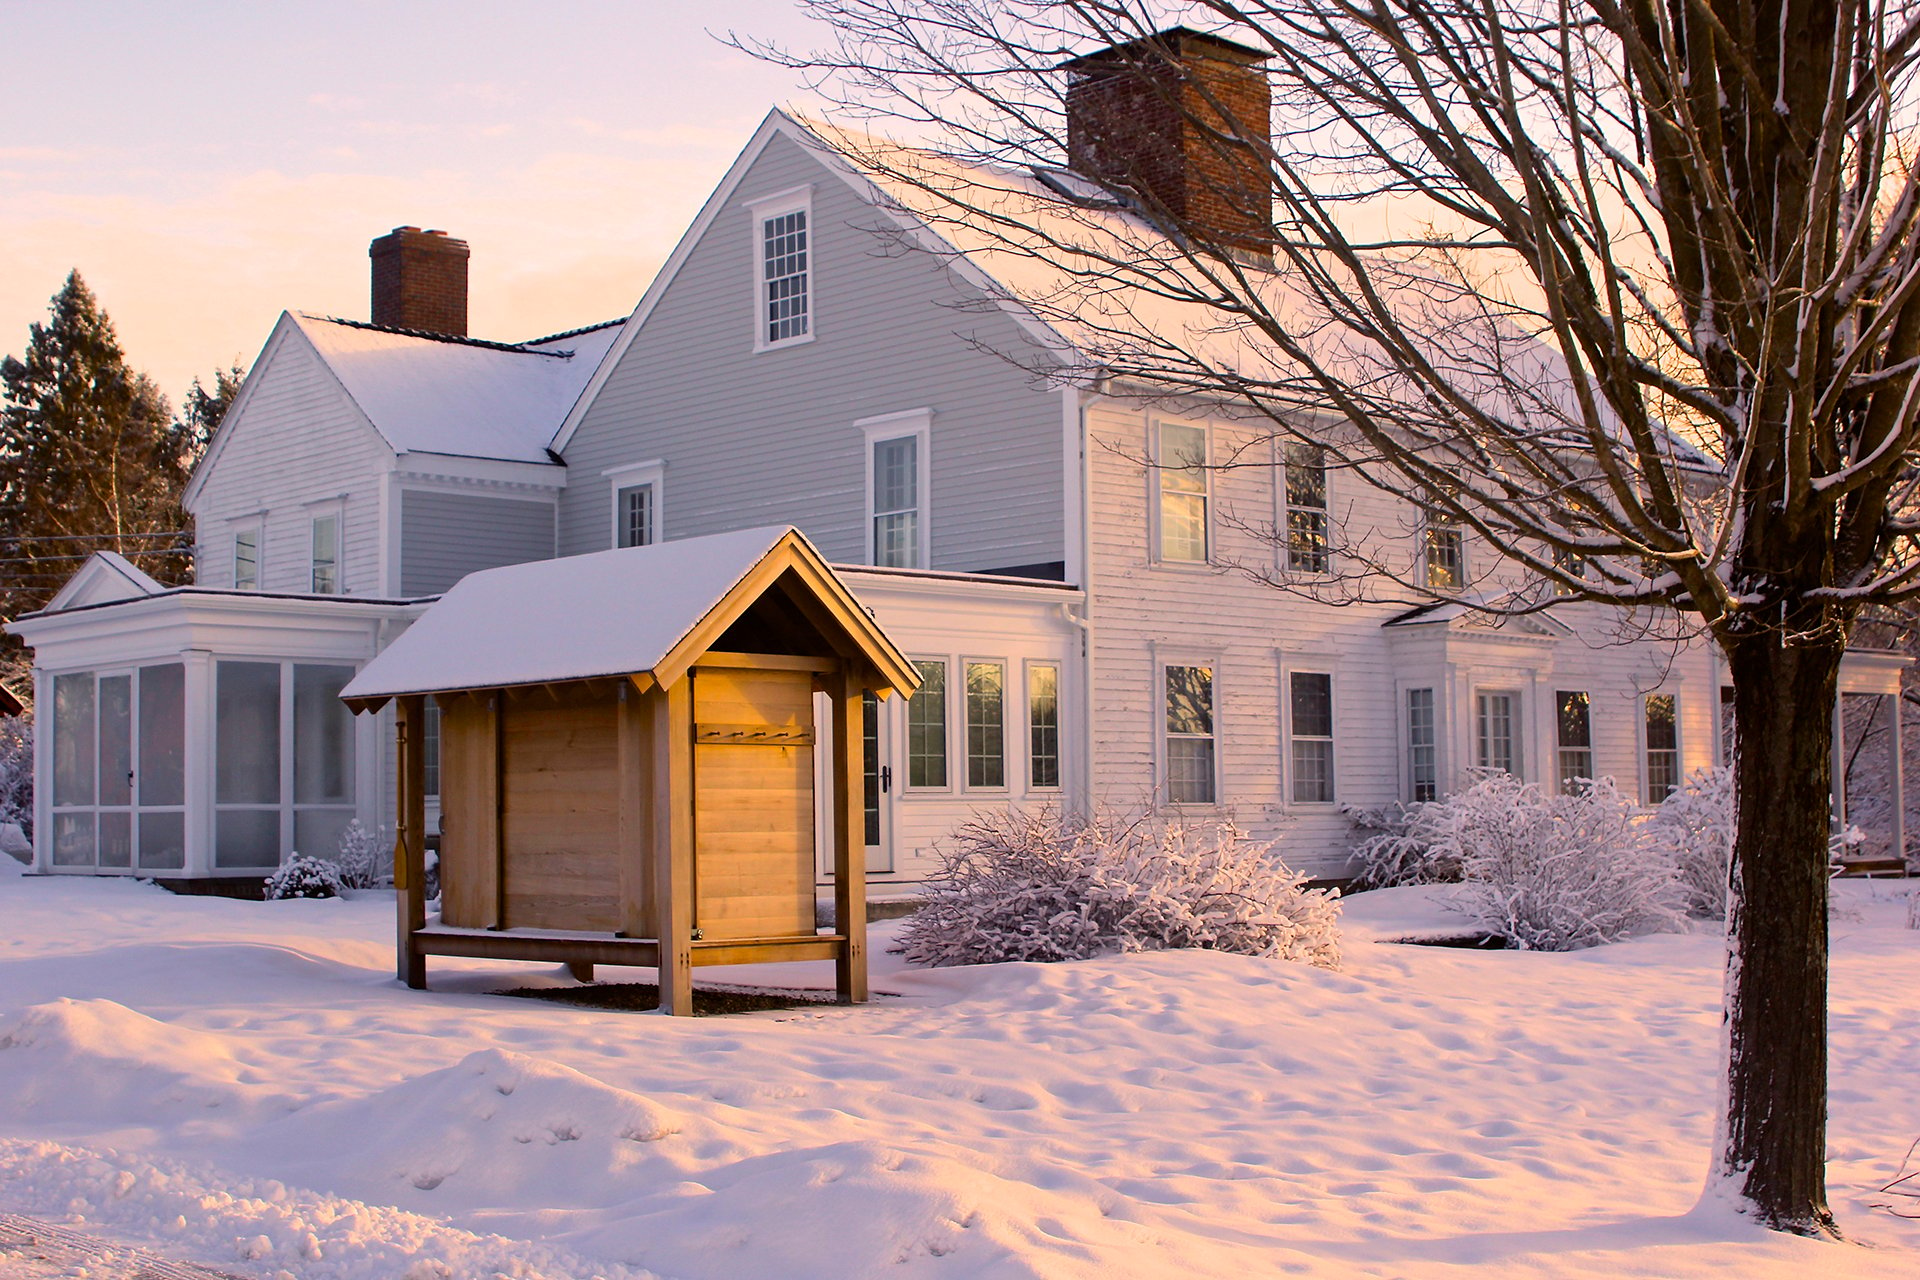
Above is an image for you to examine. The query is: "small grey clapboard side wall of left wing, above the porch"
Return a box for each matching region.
[399,489,553,597]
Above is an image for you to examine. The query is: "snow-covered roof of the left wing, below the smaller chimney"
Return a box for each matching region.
[294,313,622,462]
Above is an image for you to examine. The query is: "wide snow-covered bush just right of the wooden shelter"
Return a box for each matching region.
[899,808,1340,969]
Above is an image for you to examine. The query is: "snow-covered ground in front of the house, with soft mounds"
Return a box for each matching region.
[0,860,1920,1280]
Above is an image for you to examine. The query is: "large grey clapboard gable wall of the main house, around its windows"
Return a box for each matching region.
[561,134,1068,570]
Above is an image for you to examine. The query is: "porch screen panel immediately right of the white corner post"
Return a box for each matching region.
[213,662,280,867]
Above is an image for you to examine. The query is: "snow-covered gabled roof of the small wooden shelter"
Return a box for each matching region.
[340,526,918,710]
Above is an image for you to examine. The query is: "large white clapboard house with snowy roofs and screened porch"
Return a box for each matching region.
[12,27,1899,892]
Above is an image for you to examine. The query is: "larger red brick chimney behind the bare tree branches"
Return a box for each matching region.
[1066,27,1273,257]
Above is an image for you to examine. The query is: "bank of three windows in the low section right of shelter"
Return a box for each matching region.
[902,658,1060,791]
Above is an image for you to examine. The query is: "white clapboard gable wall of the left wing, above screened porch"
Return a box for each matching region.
[192,324,394,595]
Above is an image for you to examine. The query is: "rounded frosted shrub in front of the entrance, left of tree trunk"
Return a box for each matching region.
[1428,773,1684,952]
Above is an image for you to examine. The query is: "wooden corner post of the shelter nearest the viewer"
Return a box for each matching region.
[647,674,693,1015]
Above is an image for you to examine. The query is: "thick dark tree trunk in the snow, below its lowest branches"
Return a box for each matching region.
[1716,629,1845,1236]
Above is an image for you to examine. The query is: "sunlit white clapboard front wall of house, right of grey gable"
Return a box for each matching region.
[1087,401,1718,875]
